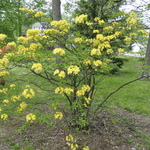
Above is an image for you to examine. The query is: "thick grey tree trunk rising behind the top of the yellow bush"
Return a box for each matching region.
[52,0,61,21]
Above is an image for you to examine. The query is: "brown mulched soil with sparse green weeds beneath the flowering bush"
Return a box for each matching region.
[0,108,150,150]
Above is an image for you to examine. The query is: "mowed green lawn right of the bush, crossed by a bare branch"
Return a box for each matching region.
[96,56,150,116]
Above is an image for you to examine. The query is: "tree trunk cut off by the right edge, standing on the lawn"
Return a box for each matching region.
[139,32,150,79]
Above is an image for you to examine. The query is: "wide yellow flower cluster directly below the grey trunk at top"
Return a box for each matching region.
[51,20,70,32]
